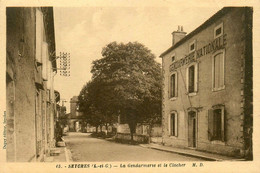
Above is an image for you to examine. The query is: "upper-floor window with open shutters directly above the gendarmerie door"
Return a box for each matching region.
[186,64,198,93]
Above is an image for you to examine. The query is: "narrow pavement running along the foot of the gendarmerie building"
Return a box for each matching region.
[140,143,244,161]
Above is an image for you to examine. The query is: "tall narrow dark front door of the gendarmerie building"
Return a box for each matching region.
[188,111,197,148]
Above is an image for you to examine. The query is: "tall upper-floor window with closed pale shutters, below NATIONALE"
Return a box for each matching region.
[212,51,225,91]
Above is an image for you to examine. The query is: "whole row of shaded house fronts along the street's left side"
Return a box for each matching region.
[6,7,56,162]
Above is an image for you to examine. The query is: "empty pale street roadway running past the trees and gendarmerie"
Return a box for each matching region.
[64,132,200,162]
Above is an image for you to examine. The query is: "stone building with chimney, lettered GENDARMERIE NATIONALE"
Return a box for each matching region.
[160,7,253,159]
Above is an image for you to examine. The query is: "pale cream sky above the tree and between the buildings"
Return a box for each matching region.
[54,6,222,112]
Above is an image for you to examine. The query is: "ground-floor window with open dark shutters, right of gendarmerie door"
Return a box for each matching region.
[208,106,225,141]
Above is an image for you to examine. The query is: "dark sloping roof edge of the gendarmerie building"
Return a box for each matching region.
[160,7,243,57]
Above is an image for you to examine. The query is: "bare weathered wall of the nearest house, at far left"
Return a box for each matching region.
[6,8,36,161]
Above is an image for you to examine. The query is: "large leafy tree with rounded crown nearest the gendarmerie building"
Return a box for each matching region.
[91,42,161,140]
